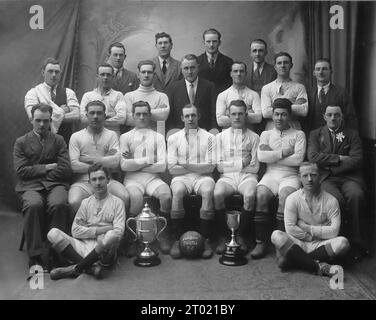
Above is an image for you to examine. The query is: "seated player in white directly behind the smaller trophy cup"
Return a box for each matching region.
[214,100,260,253]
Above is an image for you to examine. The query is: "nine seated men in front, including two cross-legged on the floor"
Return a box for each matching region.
[14,98,364,279]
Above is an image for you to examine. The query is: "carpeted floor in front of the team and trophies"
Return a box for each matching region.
[0,210,376,300]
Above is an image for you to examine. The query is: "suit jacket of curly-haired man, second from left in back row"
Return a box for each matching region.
[153,57,183,93]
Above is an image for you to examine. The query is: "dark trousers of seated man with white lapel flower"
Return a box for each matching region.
[322,177,366,245]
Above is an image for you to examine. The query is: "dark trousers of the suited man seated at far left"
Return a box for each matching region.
[21,186,70,257]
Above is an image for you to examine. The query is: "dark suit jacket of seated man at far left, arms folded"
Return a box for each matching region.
[13,131,72,192]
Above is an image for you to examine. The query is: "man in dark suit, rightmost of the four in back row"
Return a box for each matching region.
[247,39,277,95]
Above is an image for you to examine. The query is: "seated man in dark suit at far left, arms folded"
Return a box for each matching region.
[13,103,71,266]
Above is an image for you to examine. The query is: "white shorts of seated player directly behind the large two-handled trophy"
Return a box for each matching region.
[124,172,168,196]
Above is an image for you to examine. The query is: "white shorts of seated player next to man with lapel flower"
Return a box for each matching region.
[257,171,301,196]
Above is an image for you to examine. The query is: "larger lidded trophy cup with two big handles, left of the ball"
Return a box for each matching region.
[126,203,167,267]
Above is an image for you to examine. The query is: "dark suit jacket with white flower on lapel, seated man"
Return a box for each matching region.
[307,126,363,184]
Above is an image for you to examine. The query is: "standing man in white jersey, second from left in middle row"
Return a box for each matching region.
[80,63,126,136]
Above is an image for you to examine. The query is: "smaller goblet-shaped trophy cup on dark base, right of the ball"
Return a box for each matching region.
[219,211,248,266]
